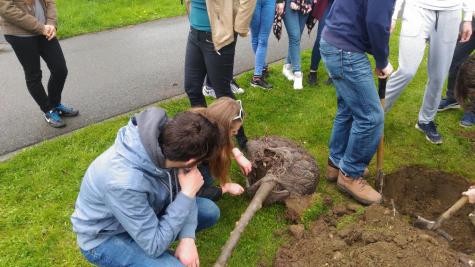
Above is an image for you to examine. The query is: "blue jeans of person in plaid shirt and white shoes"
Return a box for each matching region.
[284,1,308,72]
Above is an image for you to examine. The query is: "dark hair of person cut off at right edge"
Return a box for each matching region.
[455,54,475,110]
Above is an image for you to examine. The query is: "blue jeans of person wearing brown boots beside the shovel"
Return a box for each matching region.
[320,39,384,178]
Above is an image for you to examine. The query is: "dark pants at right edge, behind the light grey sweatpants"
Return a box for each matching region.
[446,20,475,110]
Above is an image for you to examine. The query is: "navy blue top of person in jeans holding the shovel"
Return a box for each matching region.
[322,0,395,69]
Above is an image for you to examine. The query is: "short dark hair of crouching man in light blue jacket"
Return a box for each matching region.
[160,111,219,161]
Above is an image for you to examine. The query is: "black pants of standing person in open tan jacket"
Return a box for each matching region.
[185,28,247,149]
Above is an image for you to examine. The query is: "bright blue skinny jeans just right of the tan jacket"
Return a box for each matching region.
[251,0,275,76]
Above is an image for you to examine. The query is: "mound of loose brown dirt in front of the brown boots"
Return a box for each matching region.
[274,205,466,267]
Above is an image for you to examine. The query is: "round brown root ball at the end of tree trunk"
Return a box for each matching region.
[247,136,319,204]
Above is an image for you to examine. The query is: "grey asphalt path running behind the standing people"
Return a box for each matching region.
[0,17,315,156]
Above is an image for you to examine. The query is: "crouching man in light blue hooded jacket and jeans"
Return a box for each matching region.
[71,108,219,266]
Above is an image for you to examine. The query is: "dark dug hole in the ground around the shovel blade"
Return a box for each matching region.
[383,166,475,254]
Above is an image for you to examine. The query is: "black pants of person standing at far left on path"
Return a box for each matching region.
[5,35,68,112]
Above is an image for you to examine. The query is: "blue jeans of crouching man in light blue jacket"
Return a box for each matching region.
[81,197,220,267]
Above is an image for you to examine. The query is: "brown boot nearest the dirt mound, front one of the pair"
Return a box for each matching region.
[337,172,382,205]
